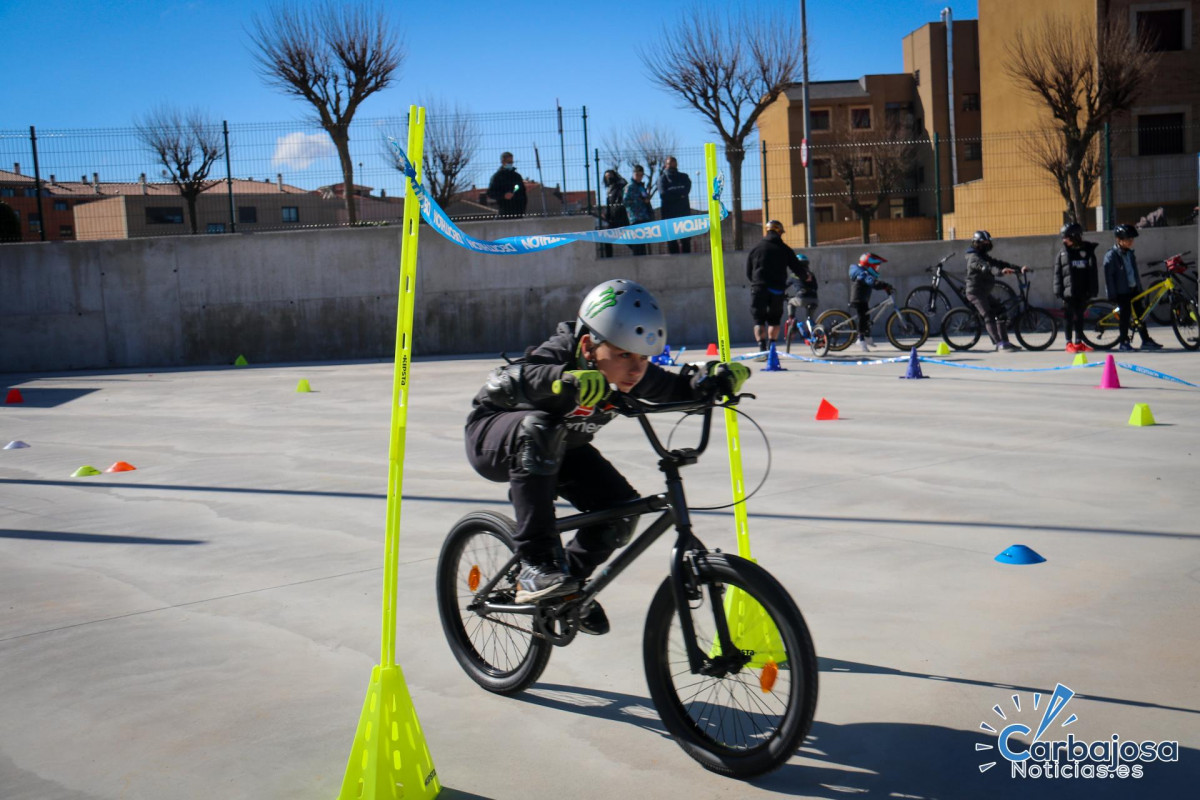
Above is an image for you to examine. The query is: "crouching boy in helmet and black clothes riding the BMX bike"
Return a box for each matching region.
[466,279,750,634]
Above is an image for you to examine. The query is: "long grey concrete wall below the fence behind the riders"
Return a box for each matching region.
[0,217,1200,372]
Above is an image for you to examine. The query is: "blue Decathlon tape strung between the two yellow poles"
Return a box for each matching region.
[388,138,730,255]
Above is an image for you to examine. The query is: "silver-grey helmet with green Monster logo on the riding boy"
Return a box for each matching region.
[575,278,667,356]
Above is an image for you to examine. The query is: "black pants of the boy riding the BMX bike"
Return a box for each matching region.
[466,411,637,578]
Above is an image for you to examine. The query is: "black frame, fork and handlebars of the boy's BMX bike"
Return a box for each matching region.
[468,395,752,675]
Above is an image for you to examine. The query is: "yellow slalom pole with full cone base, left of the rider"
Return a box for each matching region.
[337,106,442,800]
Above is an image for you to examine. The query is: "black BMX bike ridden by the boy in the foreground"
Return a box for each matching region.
[437,395,817,777]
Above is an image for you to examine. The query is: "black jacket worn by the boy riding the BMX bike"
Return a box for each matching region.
[467,321,707,447]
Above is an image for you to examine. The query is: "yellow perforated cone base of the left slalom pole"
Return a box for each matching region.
[337,664,442,800]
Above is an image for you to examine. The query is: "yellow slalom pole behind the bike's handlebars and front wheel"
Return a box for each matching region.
[704,143,787,669]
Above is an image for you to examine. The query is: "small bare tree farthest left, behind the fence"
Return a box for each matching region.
[134,106,224,234]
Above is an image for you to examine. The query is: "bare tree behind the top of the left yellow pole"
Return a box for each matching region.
[383,100,480,207]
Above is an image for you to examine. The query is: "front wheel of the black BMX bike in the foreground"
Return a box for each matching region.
[642,553,817,778]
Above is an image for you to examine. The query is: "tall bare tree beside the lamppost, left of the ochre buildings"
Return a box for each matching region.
[638,6,800,249]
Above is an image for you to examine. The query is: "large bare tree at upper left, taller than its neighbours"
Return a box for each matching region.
[250,0,406,224]
